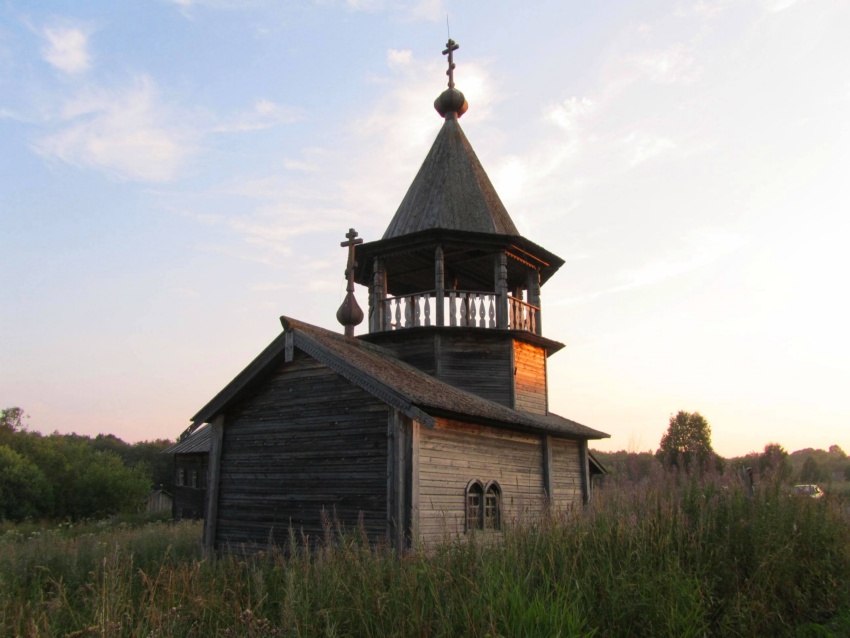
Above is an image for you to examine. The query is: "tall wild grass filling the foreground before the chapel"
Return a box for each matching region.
[0,473,850,637]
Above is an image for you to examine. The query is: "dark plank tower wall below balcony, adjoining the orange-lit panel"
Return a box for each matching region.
[437,330,513,407]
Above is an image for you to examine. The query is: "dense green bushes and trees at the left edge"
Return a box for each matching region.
[0,407,172,521]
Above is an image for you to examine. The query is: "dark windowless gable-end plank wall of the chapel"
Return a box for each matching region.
[215,351,388,547]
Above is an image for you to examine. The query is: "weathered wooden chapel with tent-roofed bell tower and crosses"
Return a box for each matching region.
[189,41,608,549]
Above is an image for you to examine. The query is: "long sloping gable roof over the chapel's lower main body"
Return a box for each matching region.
[192,317,608,439]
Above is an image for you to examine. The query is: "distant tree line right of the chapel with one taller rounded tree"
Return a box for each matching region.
[594,410,850,484]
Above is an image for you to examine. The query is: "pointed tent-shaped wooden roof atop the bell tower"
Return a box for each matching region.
[383,118,519,239]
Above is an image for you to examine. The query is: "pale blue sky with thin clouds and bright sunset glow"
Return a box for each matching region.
[0,0,850,456]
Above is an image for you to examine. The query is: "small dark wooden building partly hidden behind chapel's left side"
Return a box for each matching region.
[162,426,210,521]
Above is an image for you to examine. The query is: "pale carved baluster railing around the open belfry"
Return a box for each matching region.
[372,290,540,334]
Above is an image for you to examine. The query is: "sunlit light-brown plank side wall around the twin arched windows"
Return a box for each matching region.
[418,419,546,546]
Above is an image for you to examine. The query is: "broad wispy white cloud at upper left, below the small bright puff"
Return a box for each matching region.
[34,76,193,182]
